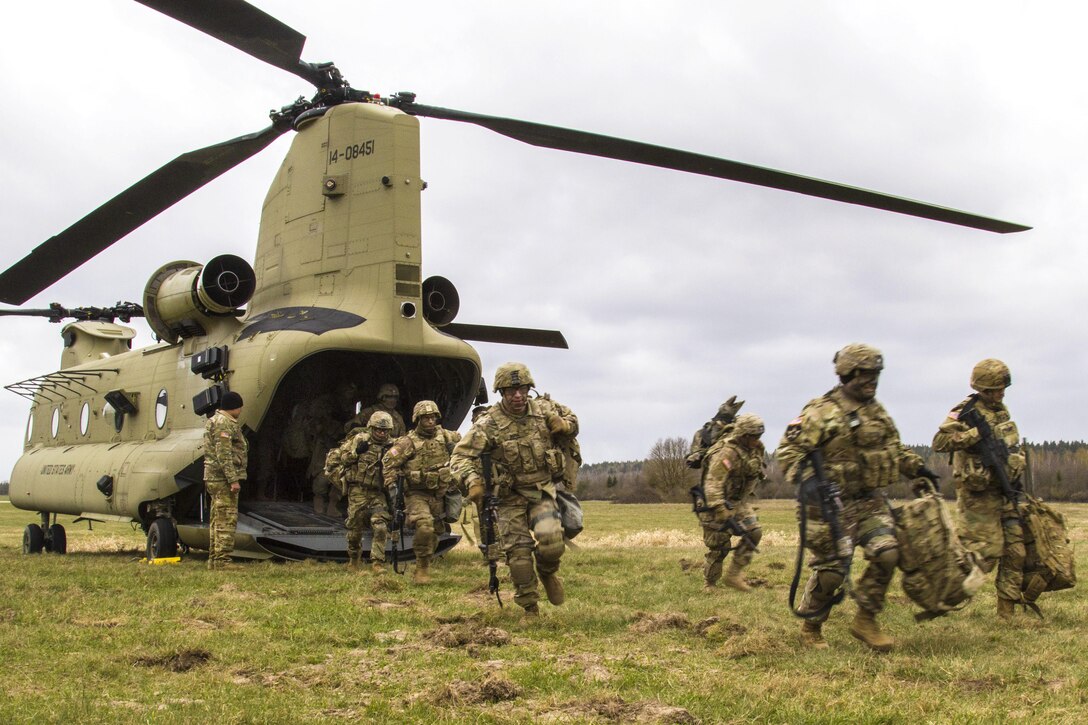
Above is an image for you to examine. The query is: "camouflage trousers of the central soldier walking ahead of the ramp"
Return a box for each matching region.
[498,491,565,607]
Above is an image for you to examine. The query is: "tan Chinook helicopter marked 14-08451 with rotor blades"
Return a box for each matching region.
[0,0,1028,560]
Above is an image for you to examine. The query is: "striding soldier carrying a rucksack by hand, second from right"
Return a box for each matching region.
[775,344,934,652]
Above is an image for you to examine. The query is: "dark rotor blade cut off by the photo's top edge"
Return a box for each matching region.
[136,0,322,85]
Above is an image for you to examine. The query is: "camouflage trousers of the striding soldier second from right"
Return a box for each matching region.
[798,496,899,622]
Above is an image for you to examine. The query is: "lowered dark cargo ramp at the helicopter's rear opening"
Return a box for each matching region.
[177,501,460,562]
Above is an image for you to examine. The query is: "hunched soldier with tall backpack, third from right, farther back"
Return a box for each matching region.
[698,415,767,591]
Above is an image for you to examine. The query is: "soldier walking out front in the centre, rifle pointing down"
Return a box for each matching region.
[450,363,578,616]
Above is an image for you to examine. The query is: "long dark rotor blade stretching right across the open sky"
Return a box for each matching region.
[399,103,1031,234]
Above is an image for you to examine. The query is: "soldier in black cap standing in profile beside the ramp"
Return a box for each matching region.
[203,392,249,569]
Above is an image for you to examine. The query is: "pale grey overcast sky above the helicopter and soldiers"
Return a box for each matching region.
[0,0,1088,479]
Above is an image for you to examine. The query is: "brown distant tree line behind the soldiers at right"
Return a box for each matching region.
[578,438,1088,503]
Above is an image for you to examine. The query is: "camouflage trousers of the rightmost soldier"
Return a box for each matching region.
[955,487,1027,602]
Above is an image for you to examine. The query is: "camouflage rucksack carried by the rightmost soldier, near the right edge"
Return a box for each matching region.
[1021,495,1077,602]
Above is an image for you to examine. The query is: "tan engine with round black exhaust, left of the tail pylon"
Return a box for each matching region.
[144,255,257,343]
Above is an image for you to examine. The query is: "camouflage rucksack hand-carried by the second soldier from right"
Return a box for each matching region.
[888,489,986,622]
